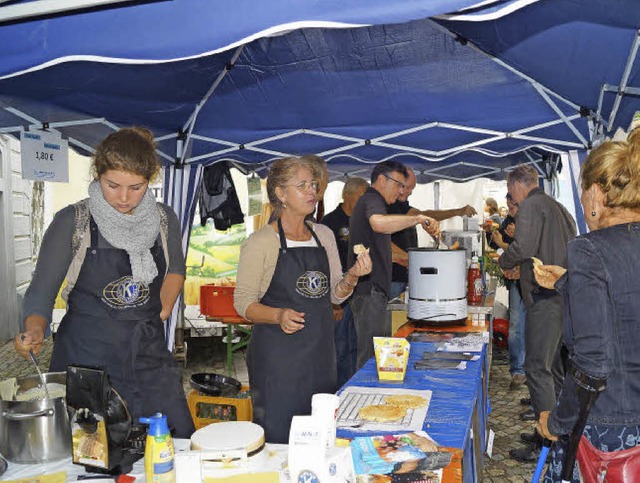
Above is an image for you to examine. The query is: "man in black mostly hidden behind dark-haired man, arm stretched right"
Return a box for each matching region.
[388,168,476,299]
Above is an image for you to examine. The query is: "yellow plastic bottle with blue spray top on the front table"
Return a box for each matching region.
[140,413,176,483]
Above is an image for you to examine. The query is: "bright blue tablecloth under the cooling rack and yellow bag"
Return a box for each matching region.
[337,342,488,481]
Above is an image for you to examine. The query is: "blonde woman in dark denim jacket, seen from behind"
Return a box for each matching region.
[534,129,640,482]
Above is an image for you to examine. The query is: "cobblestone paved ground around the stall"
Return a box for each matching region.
[0,337,535,483]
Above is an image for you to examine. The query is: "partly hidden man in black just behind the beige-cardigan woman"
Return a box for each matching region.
[322,178,369,387]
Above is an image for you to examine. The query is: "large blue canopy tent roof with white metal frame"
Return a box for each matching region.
[0,0,640,346]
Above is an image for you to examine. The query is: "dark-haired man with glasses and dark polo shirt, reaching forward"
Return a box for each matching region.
[347,161,440,368]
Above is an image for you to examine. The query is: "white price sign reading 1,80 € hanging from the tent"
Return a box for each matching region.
[20,131,69,183]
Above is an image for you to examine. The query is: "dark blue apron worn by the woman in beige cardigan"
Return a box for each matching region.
[247,220,336,443]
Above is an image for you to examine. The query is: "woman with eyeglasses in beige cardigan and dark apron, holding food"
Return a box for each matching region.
[234,158,371,443]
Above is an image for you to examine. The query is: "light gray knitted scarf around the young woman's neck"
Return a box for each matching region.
[89,181,160,285]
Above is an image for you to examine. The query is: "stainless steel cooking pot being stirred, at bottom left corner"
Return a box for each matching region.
[0,372,71,464]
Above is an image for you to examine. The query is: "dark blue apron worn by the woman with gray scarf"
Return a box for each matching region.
[50,218,194,438]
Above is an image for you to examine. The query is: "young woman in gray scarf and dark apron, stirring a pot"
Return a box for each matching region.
[15,127,194,438]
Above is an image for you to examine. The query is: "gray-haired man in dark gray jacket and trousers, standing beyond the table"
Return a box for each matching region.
[498,165,576,461]
